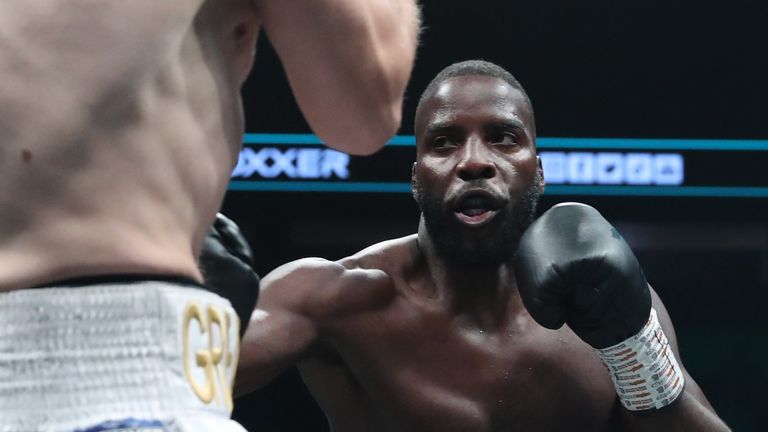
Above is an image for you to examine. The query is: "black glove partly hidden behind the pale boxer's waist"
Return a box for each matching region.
[199,213,259,337]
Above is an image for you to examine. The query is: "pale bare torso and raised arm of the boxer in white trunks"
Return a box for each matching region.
[0,0,417,291]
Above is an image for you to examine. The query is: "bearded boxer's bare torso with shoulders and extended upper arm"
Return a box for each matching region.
[238,236,648,432]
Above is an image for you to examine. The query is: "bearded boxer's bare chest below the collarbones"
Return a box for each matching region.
[328,296,615,431]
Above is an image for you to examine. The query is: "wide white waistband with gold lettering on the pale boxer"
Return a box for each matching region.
[0,281,240,432]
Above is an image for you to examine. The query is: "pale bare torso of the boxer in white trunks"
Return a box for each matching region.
[0,0,259,291]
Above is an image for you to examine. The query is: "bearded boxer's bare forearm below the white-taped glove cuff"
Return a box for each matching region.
[619,391,731,432]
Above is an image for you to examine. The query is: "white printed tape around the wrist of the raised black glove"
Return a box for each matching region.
[595,309,685,411]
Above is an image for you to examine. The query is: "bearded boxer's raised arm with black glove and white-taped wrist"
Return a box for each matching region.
[516,203,728,431]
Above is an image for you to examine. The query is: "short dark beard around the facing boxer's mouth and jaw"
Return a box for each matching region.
[416,172,542,266]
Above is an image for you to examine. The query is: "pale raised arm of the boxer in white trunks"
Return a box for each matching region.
[255,0,420,154]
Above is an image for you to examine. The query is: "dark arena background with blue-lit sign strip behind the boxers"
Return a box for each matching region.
[223,0,768,432]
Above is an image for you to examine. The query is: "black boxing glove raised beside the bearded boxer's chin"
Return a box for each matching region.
[515,203,651,348]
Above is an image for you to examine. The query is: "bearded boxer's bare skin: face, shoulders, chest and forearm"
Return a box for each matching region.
[236,70,727,432]
